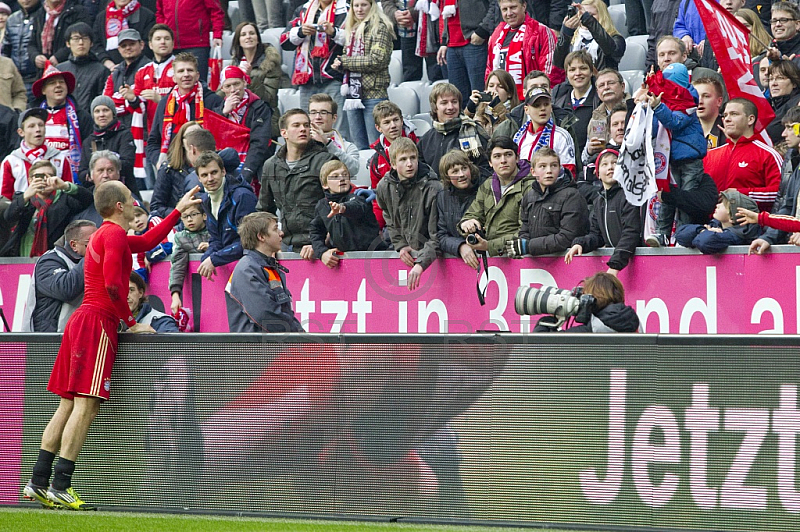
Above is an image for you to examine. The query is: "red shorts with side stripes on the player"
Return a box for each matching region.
[47,307,119,400]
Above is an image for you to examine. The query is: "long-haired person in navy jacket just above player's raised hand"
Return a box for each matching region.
[150,120,200,217]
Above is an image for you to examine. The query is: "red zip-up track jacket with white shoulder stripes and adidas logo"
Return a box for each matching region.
[703,135,783,211]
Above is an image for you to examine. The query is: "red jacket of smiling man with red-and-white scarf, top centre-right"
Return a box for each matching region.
[483,15,567,100]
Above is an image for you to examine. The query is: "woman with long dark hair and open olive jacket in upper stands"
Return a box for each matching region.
[230,22,283,136]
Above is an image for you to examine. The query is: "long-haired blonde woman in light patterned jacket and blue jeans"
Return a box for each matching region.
[333,0,394,150]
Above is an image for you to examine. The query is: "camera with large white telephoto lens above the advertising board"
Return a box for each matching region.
[514,286,596,327]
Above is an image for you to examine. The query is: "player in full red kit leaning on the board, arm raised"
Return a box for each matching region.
[23,181,200,510]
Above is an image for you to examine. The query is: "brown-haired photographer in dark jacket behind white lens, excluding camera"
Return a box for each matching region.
[533,272,639,333]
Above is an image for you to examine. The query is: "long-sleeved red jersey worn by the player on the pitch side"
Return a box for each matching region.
[81,210,180,327]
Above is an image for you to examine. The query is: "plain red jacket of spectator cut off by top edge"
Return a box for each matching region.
[156,0,225,50]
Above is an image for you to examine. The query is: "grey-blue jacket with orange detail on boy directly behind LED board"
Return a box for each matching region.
[225,249,303,333]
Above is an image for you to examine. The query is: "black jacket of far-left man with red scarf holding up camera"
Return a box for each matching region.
[0,185,92,257]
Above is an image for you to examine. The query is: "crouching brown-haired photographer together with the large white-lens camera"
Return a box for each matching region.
[528,272,639,333]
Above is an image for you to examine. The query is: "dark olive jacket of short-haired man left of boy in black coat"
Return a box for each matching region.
[258,140,335,247]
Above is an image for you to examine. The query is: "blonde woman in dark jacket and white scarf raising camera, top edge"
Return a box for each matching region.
[553,0,625,70]
